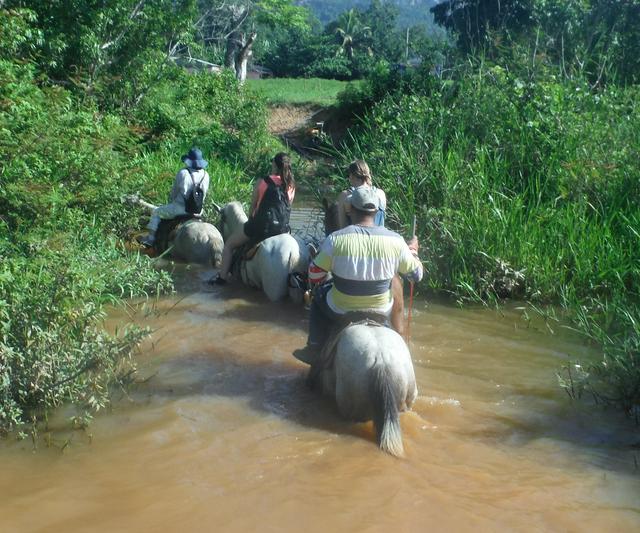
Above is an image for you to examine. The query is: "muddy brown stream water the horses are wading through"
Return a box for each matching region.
[0,207,640,532]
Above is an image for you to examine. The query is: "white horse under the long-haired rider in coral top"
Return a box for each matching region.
[220,202,310,302]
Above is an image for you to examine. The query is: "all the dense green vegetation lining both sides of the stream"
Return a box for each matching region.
[0,0,640,431]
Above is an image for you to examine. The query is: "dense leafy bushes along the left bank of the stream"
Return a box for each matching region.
[0,3,273,431]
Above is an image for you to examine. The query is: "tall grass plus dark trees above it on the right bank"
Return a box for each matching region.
[324,0,640,414]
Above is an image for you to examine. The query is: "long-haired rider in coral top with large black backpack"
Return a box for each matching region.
[213,152,296,285]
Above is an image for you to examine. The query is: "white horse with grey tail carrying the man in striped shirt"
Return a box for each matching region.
[310,323,418,457]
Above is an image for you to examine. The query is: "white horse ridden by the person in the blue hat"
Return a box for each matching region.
[122,195,224,268]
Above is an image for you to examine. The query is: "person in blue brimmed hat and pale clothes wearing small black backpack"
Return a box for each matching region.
[140,148,209,248]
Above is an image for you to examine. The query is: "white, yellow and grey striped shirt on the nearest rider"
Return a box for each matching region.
[309,225,422,314]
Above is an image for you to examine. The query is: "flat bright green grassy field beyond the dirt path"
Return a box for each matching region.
[247,78,357,106]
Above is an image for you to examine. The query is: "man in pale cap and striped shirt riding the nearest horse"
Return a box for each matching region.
[293,187,423,364]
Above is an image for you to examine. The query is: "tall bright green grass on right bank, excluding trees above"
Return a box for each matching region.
[341,67,640,411]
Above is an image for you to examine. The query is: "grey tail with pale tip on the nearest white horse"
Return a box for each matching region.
[369,361,404,457]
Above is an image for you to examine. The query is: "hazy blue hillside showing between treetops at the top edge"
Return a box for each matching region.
[295,0,439,27]
